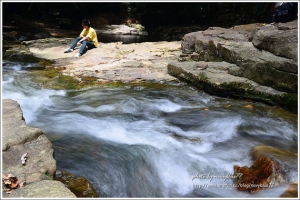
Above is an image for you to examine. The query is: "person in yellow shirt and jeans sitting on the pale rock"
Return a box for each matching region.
[64,19,99,57]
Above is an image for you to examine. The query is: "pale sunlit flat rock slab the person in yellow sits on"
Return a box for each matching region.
[24,38,181,82]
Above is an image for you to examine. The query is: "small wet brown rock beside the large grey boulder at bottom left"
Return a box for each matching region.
[55,170,98,198]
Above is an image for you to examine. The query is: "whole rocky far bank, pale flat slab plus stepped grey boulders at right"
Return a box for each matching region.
[4,20,298,113]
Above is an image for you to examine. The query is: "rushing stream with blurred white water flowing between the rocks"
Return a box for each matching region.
[2,60,298,198]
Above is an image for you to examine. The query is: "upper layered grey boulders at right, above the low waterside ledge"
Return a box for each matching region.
[181,21,298,93]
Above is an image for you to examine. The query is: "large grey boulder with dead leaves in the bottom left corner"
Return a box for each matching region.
[2,99,75,198]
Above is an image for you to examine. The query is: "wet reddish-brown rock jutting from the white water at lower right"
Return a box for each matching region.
[234,156,284,193]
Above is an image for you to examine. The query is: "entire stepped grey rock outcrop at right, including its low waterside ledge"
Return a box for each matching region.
[168,20,298,113]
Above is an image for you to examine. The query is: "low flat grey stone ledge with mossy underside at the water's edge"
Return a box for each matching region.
[167,61,298,112]
